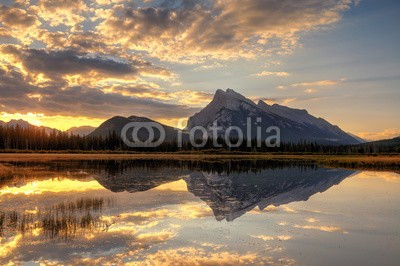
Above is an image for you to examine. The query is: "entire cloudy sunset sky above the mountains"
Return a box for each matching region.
[0,0,400,139]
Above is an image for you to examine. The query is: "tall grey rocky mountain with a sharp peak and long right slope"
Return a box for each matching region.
[187,89,360,145]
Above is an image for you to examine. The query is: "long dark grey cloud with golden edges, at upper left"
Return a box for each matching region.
[0,45,172,85]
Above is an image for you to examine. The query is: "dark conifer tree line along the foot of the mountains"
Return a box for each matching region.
[0,125,400,154]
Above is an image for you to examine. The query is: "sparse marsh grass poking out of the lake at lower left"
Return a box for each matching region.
[0,197,114,241]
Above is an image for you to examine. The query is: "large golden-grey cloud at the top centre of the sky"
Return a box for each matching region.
[97,0,360,62]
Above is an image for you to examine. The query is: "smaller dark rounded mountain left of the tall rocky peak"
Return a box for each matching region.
[89,116,184,141]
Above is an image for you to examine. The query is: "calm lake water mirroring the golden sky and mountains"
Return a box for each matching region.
[0,161,400,265]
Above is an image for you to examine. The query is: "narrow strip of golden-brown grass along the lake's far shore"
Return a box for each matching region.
[0,153,400,170]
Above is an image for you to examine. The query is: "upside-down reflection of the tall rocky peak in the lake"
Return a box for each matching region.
[184,167,356,222]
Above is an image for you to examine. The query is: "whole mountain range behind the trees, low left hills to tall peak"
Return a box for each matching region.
[6,89,396,145]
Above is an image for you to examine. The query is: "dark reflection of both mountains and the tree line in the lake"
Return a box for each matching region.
[0,160,355,221]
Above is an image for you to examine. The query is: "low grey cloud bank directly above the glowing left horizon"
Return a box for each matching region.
[0,67,198,119]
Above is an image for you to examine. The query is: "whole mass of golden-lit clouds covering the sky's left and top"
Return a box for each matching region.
[0,0,360,129]
